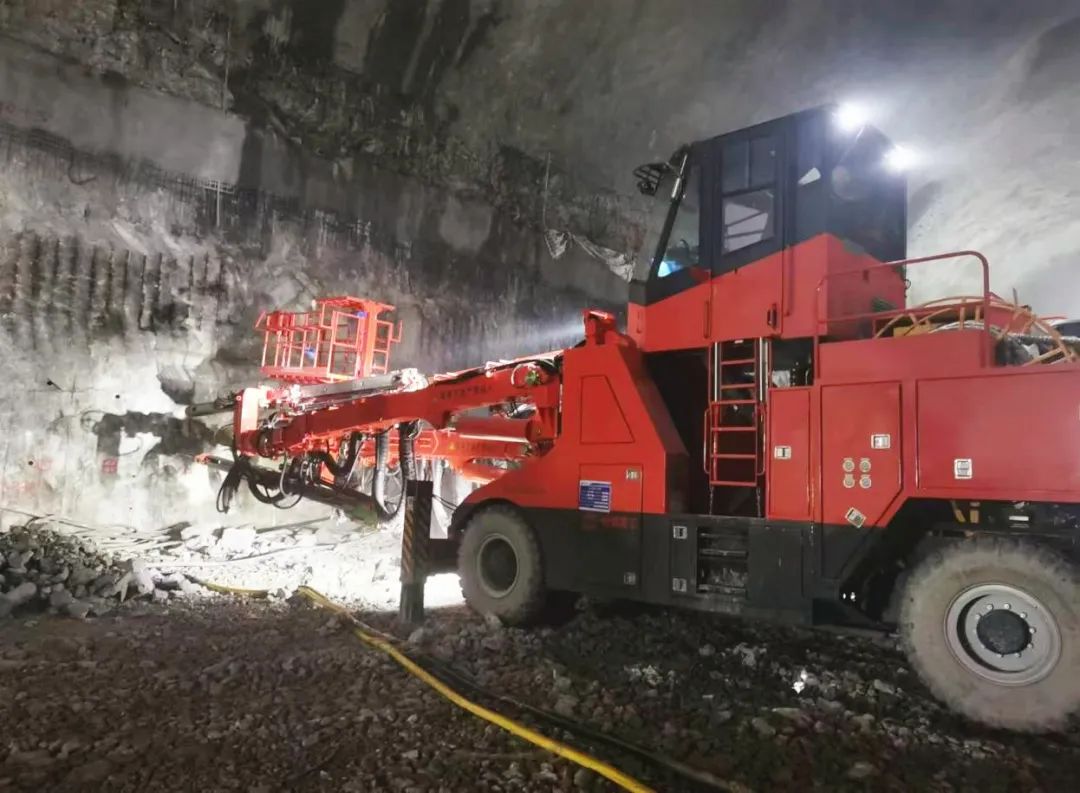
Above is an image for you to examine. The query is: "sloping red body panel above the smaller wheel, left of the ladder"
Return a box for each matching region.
[465,338,686,514]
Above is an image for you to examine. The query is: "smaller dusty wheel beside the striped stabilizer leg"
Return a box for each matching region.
[458,507,548,626]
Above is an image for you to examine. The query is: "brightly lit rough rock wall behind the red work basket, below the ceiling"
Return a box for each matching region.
[0,15,625,534]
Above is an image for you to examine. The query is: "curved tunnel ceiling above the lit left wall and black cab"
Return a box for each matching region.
[0,0,1080,313]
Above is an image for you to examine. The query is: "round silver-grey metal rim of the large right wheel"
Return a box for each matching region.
[945,583,1062,686]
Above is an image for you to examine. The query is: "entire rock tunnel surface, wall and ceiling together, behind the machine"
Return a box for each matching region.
[0,0,1080,538]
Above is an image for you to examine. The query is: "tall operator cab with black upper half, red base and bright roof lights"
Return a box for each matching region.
[630,106,906,351]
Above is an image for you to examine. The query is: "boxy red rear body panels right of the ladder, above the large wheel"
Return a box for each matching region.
[766,331,1080,526]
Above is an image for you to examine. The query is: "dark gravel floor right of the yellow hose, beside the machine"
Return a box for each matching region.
[373,606,1080,793]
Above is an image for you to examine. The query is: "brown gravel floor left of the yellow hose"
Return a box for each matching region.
[0,601,600,793]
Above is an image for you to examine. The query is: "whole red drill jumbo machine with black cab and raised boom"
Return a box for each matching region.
[200,107,1080,729]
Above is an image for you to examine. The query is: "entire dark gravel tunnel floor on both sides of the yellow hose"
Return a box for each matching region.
[0,599,1080,793]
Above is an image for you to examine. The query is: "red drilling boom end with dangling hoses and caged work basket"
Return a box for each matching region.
[189,297,540,521]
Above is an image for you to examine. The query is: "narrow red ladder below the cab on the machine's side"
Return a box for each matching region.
[705,339,761,487]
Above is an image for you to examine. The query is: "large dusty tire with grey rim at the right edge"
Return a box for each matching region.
[900,539,1080,731]
